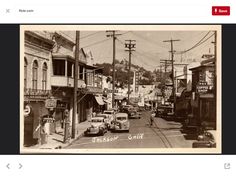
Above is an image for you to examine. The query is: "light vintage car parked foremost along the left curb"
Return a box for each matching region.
[85,117,107,135]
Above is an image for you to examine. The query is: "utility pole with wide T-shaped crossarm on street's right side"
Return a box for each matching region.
[163,39,180,113]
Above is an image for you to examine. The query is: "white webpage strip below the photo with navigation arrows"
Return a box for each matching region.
[0,155,236,177]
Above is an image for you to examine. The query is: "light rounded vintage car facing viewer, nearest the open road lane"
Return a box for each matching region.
[111,113,130,132]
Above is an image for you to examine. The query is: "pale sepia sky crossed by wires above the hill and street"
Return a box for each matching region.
[63,31,214,71]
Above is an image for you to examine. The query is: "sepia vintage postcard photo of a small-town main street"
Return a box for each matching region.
[21,25,221,152]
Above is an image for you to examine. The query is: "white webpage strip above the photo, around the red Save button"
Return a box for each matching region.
[0,0,236,23]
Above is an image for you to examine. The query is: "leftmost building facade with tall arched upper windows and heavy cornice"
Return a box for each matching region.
[24,31,54,146]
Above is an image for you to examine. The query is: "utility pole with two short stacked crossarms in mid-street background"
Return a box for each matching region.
[125,40,136,104]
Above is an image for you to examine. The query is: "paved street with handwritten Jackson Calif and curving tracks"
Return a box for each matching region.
[67,112,192,149]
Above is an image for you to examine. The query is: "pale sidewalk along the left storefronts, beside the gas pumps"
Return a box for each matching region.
[25,121,90,149]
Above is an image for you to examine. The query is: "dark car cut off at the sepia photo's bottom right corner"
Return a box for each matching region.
[192,130,216,148]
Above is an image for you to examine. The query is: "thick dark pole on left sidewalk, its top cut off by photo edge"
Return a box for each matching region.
[71,31,80,138]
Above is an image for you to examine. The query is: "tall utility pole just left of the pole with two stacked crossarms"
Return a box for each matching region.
[106,30,121,108]
